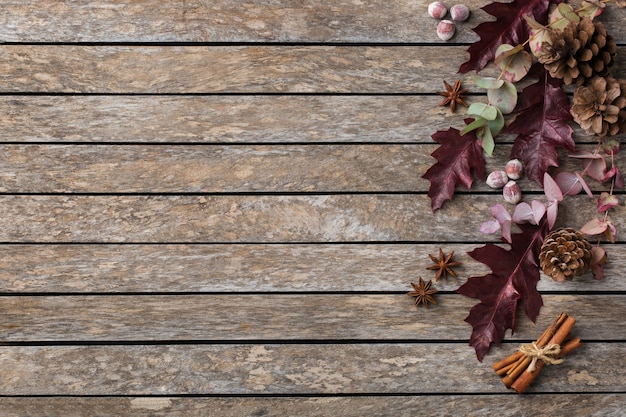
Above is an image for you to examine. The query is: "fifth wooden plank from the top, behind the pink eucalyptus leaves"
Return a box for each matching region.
[0,194,626,243]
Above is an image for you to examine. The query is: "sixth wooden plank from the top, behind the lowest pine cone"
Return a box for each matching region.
[0,243,626,293]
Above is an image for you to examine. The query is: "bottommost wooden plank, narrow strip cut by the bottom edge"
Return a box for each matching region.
[0,393,626,417]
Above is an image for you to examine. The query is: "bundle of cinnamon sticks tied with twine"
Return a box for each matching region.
[493,313,582,394]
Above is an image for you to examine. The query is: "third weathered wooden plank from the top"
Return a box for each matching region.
[0,94,616,144]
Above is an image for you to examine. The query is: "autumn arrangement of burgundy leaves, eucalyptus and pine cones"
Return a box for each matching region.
[416,0,626,361]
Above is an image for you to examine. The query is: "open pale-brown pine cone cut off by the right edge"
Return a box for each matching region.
[570,77,626,136]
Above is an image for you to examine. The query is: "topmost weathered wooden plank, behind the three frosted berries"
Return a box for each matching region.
[0,0,626,43]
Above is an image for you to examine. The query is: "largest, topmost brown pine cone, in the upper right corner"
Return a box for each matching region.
[537,17,617,85]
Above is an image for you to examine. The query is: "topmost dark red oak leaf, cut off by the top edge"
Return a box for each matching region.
[459,0,562,73]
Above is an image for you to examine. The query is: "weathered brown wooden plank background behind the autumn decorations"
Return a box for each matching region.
[0,0,626,416]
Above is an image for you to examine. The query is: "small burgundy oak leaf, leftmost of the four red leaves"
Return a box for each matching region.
[422,128,485,212]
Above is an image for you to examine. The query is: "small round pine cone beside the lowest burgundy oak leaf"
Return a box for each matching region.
[539,227,591,282]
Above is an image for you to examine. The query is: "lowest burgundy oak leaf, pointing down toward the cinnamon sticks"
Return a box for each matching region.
[457,216,548,361]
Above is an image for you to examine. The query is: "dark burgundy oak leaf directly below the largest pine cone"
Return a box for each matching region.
[503,65,576,185]
